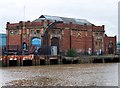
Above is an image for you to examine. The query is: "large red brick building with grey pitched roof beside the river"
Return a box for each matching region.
[6,15,116,54]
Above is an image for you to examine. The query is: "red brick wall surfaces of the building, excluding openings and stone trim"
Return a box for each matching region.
[6,21,116,54]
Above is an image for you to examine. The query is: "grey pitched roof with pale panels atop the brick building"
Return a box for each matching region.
[34,15,92,25]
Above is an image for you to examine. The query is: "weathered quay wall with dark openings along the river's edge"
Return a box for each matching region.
[0,55,120,67]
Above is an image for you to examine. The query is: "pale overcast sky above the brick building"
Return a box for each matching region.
[0,0,119,40]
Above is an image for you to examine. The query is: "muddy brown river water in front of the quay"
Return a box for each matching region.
[0,63,118,86]
